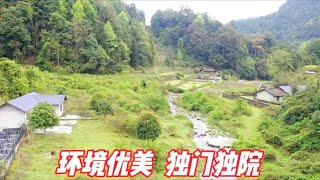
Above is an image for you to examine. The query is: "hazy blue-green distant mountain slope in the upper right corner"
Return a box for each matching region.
[234,0,320,41]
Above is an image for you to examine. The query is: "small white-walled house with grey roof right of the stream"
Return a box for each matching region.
[255,85,306,103]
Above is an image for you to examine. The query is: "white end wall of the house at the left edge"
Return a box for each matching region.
[0,104,27,129]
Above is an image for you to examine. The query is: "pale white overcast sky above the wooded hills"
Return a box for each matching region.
[124,0,286,25]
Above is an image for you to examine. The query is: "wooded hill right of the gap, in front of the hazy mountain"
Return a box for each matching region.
[151,9,320,80]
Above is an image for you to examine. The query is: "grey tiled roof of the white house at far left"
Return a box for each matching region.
[7,92,66,112]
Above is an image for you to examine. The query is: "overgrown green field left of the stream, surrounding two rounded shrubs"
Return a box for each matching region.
[7,68,195,180]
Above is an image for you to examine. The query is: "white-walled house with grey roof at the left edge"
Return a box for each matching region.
[0,92,67,129]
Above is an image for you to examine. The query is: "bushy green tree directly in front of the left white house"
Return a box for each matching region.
[28,103,59,131]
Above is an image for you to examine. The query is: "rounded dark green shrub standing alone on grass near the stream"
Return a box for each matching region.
[136,112,161,141]
